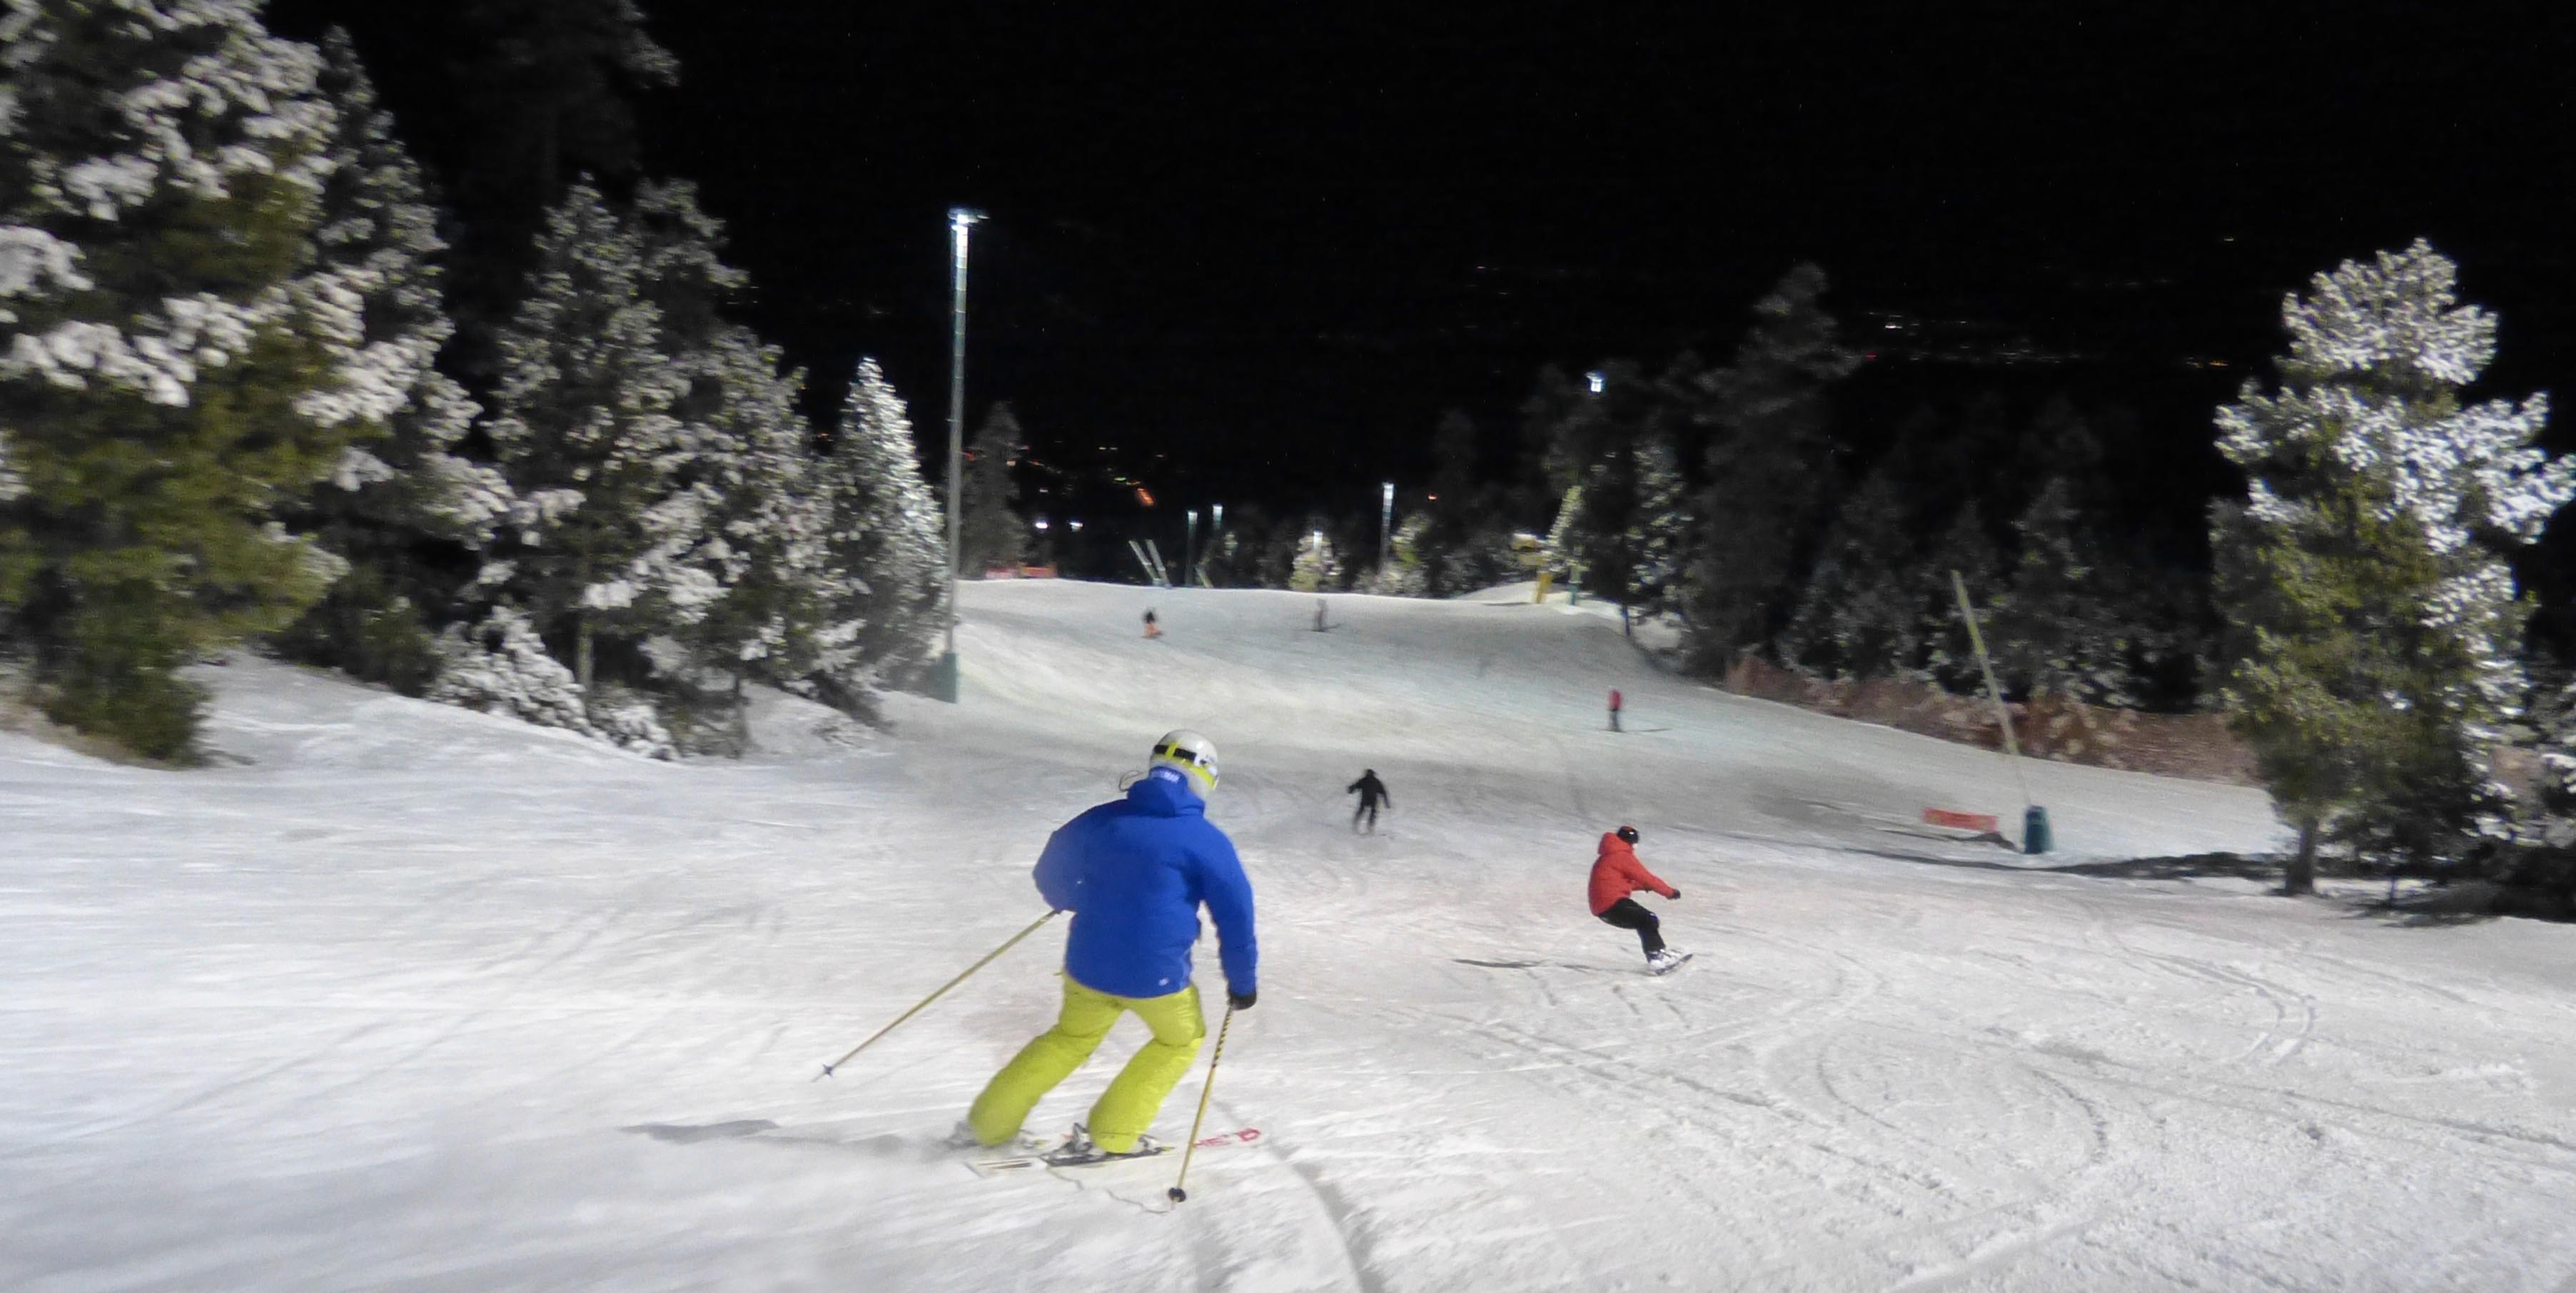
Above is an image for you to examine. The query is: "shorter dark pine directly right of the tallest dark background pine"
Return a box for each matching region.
[1777,472,1950,677]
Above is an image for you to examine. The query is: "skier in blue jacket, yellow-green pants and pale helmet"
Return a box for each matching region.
[959,731,1260,1159]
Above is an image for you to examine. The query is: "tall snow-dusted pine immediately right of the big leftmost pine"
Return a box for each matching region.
[278,29,510,696]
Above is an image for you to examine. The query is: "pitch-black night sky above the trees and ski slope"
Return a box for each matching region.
[273,0,2576,512]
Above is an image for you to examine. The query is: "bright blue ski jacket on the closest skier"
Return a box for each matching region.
[1038,768,1260,997]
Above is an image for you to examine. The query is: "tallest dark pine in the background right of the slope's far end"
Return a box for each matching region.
[1684,265,1860,669]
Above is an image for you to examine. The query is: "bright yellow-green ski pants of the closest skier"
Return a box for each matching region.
[966,973,1208,1154]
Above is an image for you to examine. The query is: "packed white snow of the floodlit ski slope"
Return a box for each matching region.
[0,582,2576,1293]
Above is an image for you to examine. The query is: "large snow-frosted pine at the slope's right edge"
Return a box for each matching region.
[2213,240,2576,894]
